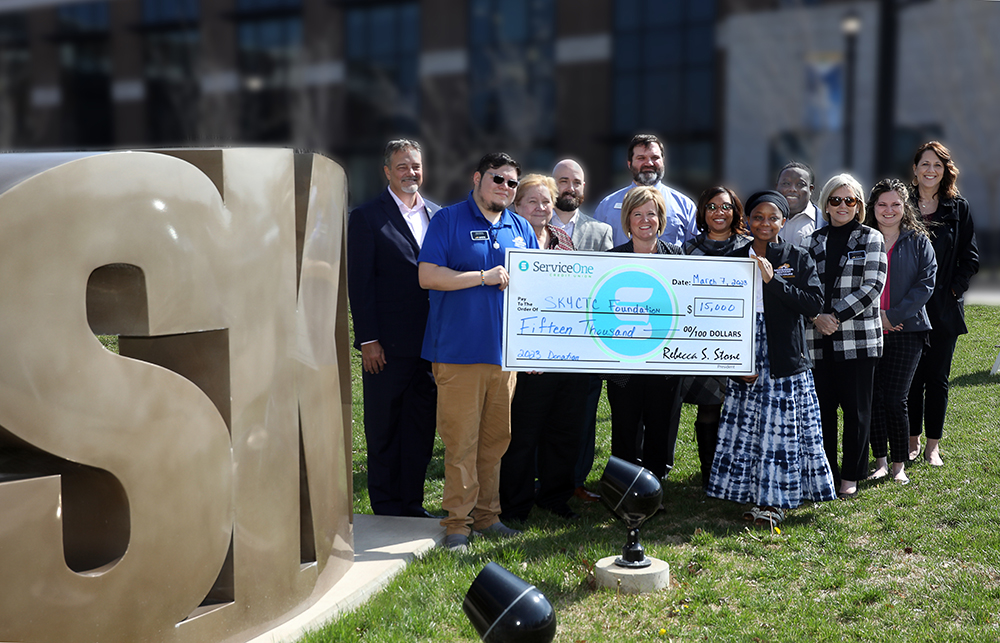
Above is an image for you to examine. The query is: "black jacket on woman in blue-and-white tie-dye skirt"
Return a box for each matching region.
[729,242,823,377]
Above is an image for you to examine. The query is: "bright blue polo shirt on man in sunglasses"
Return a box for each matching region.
[417,192,538,366]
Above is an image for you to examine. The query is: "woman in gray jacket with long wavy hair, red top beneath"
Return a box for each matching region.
[865,179,937,484]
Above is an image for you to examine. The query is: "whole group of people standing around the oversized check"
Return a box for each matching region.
[348,134,978,550]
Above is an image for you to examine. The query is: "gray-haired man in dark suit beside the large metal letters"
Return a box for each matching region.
[347,139,439,517]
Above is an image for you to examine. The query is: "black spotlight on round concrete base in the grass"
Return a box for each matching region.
[601,456,663,569]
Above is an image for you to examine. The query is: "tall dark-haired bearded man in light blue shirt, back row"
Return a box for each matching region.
[594,134,698,246]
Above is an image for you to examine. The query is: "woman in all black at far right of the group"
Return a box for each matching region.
[909,141,979,467]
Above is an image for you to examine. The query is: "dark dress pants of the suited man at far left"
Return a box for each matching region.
[361,355,437,516]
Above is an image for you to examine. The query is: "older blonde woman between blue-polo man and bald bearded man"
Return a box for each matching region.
[500,174,590,522]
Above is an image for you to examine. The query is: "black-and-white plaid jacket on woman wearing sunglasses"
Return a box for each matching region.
[806,225,886,361]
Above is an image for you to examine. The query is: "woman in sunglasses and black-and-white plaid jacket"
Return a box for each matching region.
[809,174,886,499]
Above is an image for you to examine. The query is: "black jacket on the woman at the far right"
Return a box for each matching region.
[911,190,979,335]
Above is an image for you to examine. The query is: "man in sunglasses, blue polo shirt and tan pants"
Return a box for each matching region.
[418,152,538,551]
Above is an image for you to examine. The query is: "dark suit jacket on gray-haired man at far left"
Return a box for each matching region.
[347,188,440,357]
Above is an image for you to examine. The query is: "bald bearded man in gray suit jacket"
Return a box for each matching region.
[551,159,614,502]
